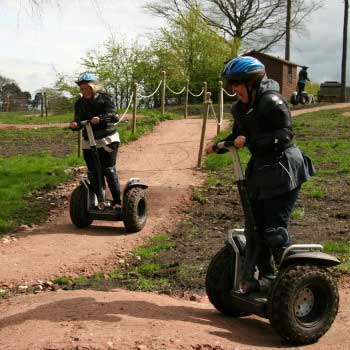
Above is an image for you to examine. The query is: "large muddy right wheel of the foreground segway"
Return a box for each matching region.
[268,265,339,345]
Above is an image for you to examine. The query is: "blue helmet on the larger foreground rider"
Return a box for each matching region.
[221,56,265,83]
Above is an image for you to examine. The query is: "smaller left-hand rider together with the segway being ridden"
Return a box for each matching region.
[70,73,147,232]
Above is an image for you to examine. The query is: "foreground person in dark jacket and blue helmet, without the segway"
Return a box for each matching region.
[206,56,314,292]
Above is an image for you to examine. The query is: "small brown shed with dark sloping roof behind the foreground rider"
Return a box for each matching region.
[244,51,299,101]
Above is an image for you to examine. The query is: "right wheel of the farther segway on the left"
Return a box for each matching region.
[123,187,147,233]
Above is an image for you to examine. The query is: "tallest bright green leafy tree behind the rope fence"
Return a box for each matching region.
[149,8,232,102]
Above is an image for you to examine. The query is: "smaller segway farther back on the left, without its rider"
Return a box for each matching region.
[70,120,148,233]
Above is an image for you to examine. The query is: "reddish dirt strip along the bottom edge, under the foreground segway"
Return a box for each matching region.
[0,289,350,350]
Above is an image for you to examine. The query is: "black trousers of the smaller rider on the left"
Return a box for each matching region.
[83,142,121,204]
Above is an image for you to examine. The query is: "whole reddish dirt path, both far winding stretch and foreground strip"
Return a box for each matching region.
[0,105,350,350]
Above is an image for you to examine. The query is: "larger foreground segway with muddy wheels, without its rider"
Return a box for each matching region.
[206,141,340,345]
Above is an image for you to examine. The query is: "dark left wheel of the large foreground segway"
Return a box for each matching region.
[205,246,250,317]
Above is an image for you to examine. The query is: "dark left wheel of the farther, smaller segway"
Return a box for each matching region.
[69,185,93,228]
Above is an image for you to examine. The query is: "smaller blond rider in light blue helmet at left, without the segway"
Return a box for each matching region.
[69,73,121,210]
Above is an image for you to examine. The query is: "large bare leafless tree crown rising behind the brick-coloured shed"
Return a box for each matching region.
[146,0,322,51]
